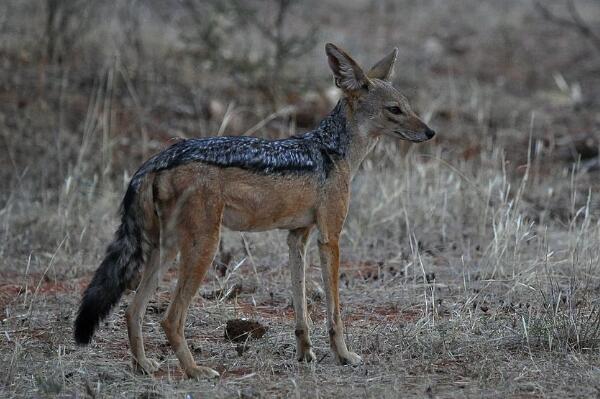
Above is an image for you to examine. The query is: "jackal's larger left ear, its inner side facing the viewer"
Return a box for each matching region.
[325,43,369,92]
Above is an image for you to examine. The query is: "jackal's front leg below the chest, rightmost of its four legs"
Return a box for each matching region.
[319,234,362,365]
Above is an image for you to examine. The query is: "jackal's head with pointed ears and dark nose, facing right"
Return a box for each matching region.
[325,43,435,142]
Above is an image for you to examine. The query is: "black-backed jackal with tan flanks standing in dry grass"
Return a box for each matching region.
[75,44,435,378]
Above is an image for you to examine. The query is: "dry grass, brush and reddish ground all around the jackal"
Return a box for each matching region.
[0,0,600,398]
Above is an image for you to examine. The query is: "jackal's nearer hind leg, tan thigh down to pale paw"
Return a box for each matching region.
[161,195,223,379]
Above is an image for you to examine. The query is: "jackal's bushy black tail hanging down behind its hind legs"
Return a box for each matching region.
[75,184,144,345]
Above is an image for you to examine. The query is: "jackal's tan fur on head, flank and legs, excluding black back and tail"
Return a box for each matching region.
[127,45,428,378]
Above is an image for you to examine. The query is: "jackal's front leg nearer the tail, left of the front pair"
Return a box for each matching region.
[287,226,316,362]
